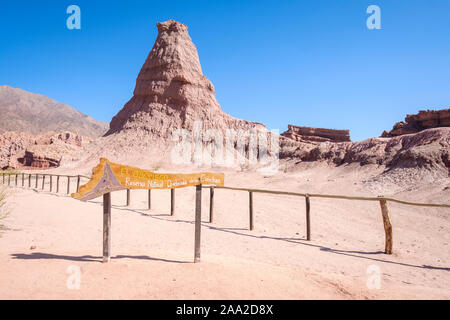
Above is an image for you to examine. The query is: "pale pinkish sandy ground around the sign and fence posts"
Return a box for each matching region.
[0,162,450,299]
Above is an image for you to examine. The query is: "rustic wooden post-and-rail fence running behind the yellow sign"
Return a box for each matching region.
[1,172,450,254]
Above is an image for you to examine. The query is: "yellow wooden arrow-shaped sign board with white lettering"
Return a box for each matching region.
[72,158,224,201]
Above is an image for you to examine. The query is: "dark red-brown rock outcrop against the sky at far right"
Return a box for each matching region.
[381,109,450,137]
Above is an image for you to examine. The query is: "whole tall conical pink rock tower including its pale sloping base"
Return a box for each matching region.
[77,20,271,166]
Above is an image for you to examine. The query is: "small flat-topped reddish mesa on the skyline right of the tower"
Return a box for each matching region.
[281,125,350,142]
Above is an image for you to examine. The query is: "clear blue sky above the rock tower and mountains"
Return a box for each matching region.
[0,0,450,140]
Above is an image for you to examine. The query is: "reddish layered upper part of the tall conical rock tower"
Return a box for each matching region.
[106,20,265,140]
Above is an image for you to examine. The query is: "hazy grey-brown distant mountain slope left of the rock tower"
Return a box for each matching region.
[0,86,109,137]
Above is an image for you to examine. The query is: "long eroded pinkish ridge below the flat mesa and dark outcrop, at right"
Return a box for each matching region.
[280,128,450,175]
